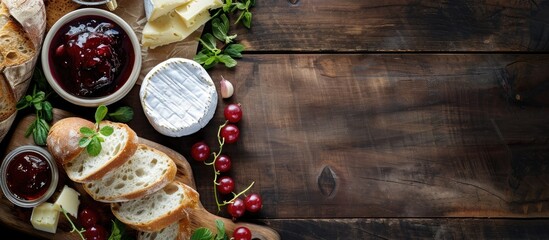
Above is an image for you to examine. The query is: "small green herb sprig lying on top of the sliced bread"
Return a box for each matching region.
[78,105,114,156]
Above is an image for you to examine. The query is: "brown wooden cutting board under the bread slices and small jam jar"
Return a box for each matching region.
[0,109,280,240]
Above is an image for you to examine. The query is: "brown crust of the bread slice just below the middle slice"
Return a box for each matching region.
[111,181,200,232]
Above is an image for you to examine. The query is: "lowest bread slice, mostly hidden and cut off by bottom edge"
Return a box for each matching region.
[137,212,192,240]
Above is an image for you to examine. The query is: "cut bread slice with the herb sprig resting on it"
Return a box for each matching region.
[63,120,138,183]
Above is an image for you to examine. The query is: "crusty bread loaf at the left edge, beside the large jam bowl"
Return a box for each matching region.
[0,0,46,141]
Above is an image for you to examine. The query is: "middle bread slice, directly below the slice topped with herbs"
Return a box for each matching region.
[83,144,177,202]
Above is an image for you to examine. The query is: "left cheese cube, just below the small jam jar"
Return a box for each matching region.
[31,202,61,233]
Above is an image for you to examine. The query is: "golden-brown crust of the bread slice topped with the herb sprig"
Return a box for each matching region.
[68,120,139,183]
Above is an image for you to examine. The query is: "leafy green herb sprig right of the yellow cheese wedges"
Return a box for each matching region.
[194,0,255,69]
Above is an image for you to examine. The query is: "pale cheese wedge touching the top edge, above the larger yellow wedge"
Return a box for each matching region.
[175,0,223,27]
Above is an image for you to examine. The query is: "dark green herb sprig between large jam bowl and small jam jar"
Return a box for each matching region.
[16,68,53,146]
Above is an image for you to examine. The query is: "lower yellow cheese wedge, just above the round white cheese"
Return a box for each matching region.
[141,12,210,48]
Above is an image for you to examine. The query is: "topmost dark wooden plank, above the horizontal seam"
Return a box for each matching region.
[229,0,549,52]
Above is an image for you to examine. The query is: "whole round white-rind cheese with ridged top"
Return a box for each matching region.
[139,58,218,137]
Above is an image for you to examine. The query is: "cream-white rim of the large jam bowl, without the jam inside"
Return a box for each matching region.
[41,7,142,107]
